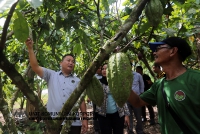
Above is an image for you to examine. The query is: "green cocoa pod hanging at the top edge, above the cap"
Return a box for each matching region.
[145,0,163,27]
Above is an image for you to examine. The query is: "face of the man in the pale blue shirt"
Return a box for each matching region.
[60,55,75,72]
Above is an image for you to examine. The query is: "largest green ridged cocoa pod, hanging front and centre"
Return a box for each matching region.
[106,52,133,107]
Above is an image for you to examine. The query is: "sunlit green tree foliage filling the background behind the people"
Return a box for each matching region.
[0,0,200,133]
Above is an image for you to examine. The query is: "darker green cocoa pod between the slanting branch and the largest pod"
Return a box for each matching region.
[86,76,104,106]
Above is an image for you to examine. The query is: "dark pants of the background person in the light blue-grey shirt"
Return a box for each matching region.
[127,102,144,134]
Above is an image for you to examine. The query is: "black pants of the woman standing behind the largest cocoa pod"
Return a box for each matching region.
[98,112,125,134]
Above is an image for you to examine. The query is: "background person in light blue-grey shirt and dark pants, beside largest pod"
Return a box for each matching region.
[127,63,144,134]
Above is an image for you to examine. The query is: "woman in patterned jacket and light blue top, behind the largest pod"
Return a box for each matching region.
[96,64,130,134]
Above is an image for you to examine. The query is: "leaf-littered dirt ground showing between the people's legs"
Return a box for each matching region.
[0,104,161,134]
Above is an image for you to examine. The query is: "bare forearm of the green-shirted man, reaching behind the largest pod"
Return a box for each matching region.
[128,90,147,107]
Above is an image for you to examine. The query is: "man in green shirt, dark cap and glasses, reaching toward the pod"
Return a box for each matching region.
[128,37,200,134]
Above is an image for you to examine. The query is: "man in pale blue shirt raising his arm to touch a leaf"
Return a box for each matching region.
[25,38,88,134]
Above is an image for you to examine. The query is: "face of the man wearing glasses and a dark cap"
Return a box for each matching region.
[153,44,171,65]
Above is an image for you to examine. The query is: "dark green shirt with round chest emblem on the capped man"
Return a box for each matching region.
[140,69,200,134]
